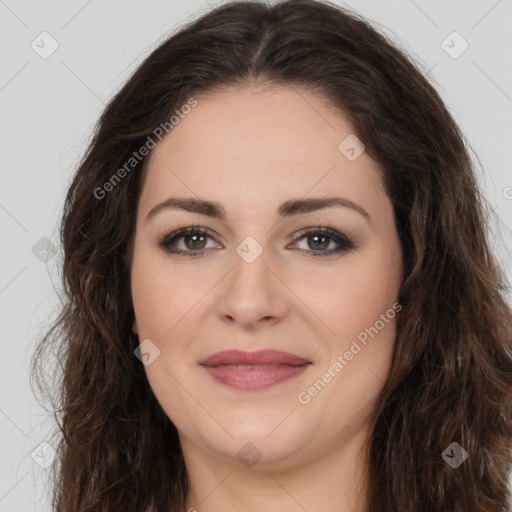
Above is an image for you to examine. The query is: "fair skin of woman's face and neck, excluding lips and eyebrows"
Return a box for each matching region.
[131,88,403,512]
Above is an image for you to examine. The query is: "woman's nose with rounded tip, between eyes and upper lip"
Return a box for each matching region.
[219,245,290,330]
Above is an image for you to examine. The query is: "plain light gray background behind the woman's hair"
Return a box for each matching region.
[0,0,512,512]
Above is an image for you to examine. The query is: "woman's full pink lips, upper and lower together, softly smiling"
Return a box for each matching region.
[199,350,311,391]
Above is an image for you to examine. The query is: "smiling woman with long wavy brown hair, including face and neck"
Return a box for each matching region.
[31,0,512,512]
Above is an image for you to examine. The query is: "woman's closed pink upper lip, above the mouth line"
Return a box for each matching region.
[199,350,311,366]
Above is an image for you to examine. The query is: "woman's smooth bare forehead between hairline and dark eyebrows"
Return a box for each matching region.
[141,87,383,216]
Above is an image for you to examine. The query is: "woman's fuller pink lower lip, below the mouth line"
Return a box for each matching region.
[204,363,309,391]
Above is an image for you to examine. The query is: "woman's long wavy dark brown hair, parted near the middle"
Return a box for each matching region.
[32,0,512,512]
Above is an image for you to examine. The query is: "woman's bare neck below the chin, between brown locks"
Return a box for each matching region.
[180,424,367,512]
